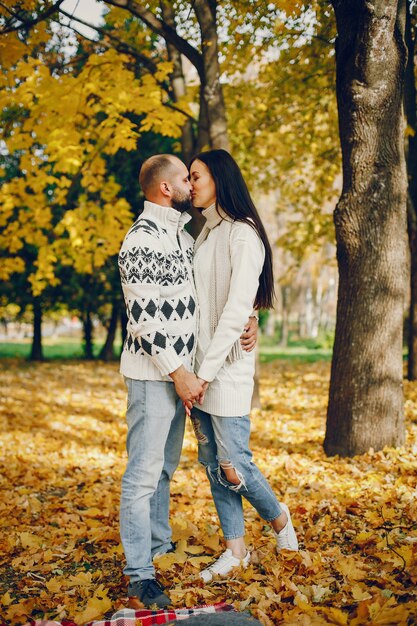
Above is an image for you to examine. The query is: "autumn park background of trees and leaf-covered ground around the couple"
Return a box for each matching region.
[0,0,417,626]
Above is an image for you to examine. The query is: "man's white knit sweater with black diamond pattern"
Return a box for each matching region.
[119,201,198,381]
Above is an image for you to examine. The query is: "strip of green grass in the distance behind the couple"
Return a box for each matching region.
[0,338,331,363]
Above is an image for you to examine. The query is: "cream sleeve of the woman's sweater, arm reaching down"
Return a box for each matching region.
[197,223,265,382]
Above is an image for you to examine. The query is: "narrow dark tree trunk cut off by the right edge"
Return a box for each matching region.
[404,0,417,380]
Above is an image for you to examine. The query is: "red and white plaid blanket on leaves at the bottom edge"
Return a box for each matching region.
[25,602,236,626]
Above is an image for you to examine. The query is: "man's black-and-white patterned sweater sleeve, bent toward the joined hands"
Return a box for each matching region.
[119,237,182,376]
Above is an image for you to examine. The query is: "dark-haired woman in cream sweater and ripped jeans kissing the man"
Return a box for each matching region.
[190,150,298,582]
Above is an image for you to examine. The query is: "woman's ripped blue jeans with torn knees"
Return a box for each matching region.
[191,408,282,539]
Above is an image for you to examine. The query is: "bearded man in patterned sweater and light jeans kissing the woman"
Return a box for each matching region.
[115,155,253,608]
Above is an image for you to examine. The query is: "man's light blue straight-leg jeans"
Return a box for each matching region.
[120,378,185,582]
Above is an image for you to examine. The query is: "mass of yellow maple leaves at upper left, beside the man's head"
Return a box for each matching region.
[0,31,185,295]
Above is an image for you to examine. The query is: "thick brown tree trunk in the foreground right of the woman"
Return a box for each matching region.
[324,0,407,456]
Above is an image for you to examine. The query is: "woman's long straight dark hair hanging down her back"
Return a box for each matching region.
[190,150,275,309]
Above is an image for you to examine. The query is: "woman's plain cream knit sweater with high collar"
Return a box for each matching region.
[194,205,265,417]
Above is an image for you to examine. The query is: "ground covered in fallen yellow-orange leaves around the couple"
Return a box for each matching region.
[0,361,417,626]
